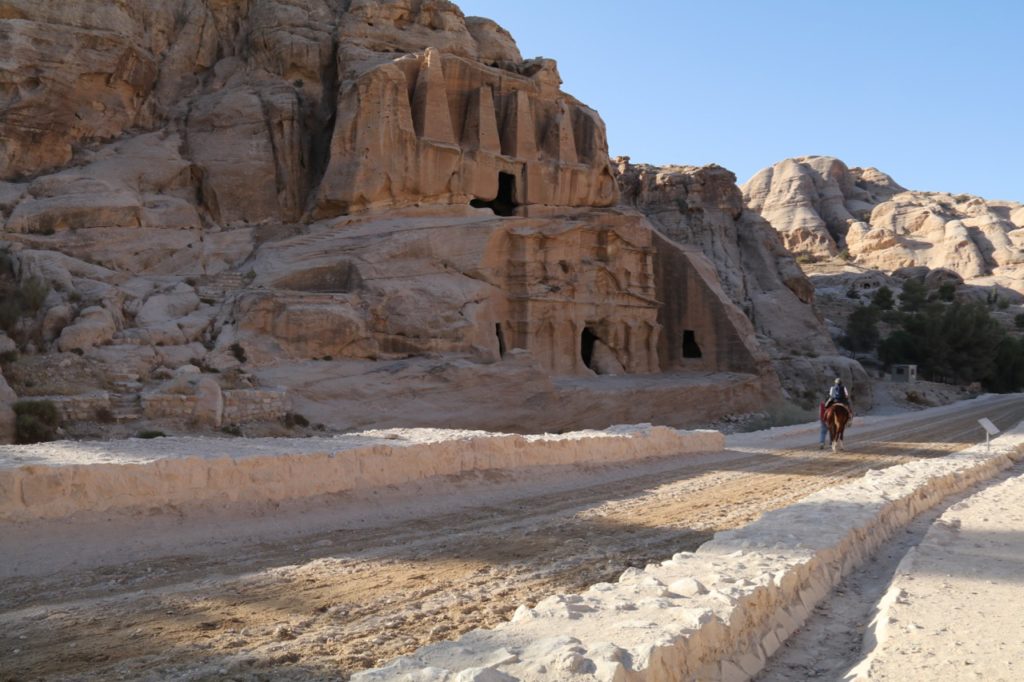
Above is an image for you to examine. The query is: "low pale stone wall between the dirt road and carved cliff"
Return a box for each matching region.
[0,424,725,520]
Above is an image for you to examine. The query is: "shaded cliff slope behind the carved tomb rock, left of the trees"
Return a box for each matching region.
[617,158,871,409]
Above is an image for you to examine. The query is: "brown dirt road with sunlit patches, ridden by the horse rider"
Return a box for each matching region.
[0,397,1024,680]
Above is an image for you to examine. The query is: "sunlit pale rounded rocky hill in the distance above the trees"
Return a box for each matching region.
[741,157,1024,295]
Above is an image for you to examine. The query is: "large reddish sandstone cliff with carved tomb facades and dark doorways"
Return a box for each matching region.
[0,0,778,430]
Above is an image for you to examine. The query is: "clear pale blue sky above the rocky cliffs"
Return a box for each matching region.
[456,0,1024,202]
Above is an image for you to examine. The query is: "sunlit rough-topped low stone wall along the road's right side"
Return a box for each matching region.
[352,427,1024,682]
